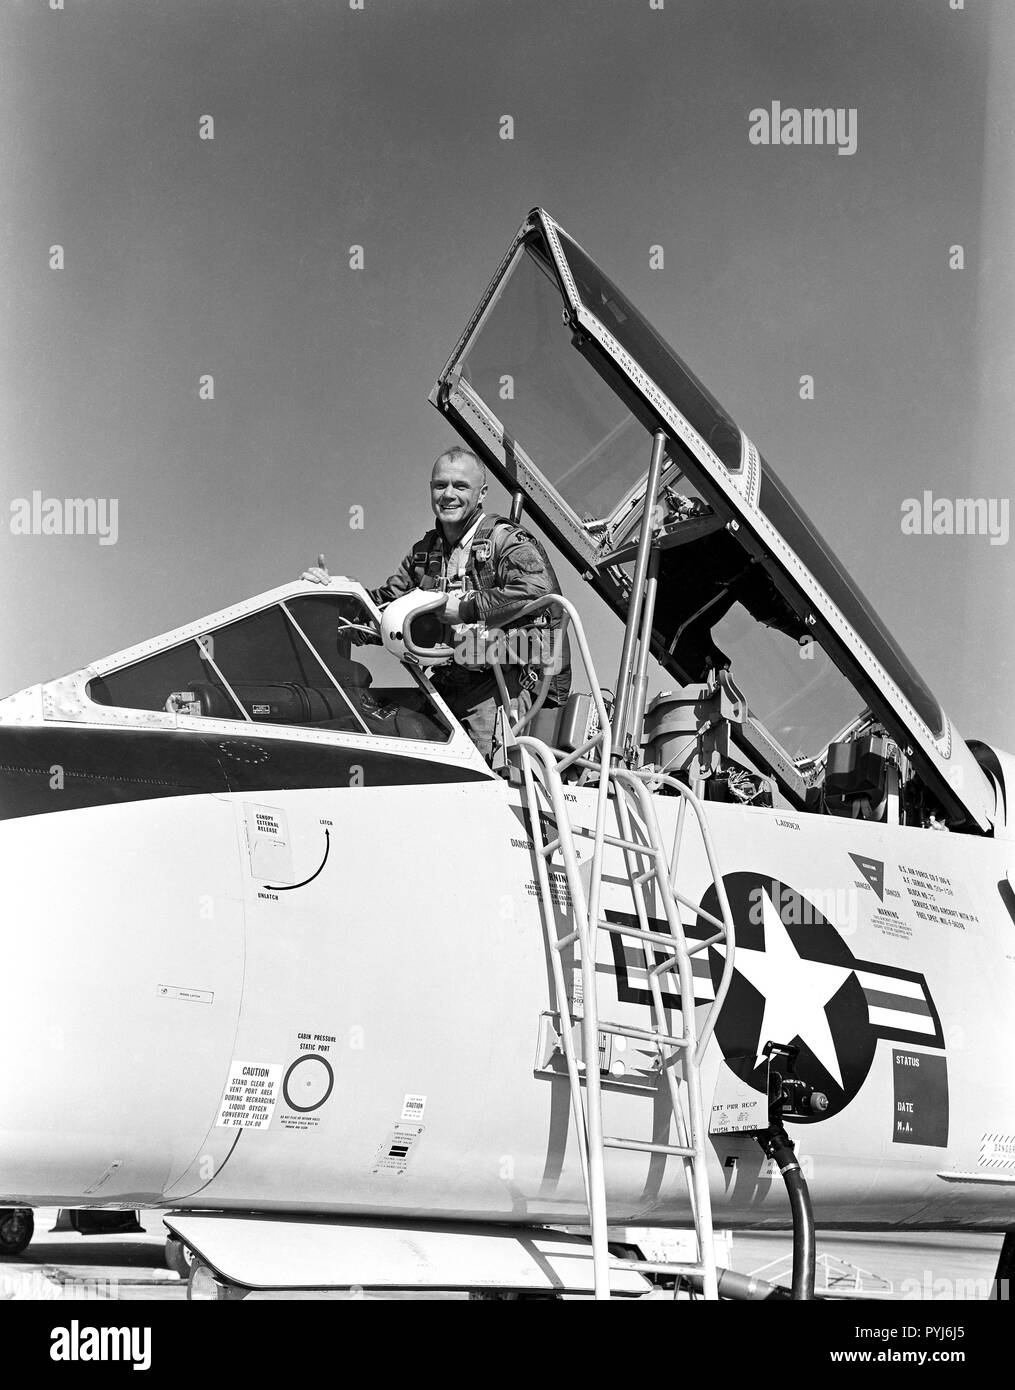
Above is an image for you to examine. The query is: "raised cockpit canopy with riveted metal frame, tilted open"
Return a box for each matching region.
[431,209,994,830]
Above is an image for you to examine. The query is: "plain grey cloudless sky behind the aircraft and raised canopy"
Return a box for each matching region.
[0,0,1015,749]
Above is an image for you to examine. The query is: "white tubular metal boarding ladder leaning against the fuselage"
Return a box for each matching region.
[494,595,736,1298]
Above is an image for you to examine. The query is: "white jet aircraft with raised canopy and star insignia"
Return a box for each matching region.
[0,209,1015,1298]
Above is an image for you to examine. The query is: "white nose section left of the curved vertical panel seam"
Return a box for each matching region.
[0,783,243,1207]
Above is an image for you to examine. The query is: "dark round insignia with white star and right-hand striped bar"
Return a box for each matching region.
[695,873,943,1123]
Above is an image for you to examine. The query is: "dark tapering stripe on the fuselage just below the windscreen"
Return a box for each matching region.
[0,726,487,820]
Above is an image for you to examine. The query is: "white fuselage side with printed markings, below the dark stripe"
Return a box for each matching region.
[0,761,1015,1229]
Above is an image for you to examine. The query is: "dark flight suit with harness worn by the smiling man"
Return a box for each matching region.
[371,514,571,760]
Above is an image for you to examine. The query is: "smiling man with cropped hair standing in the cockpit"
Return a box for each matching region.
[303,445,571,762]
